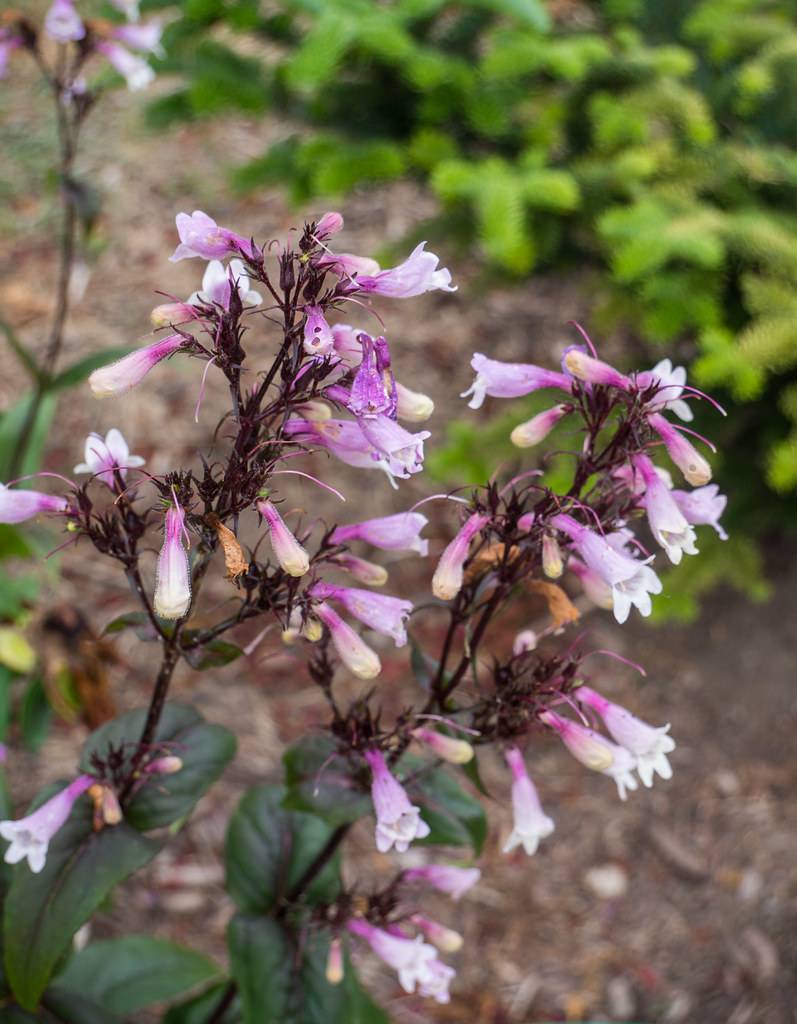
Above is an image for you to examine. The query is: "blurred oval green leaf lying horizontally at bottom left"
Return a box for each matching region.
[56,935,221,1014]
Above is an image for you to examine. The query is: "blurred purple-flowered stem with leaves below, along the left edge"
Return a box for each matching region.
[0,0,160,751]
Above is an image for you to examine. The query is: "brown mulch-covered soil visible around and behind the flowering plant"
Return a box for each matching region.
[0,44,797,1024]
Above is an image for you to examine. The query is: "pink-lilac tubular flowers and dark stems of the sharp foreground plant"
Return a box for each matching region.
[0,205,725,1001]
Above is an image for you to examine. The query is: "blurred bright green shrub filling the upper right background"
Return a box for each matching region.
[142,0,797,617]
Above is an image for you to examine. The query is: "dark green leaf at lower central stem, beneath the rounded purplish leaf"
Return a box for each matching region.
[225,783,340,913]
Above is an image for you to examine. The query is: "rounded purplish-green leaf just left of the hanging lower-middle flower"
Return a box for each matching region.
[283,735,371,825]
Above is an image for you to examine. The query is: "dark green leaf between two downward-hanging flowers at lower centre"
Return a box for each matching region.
[402,758,487,854]
